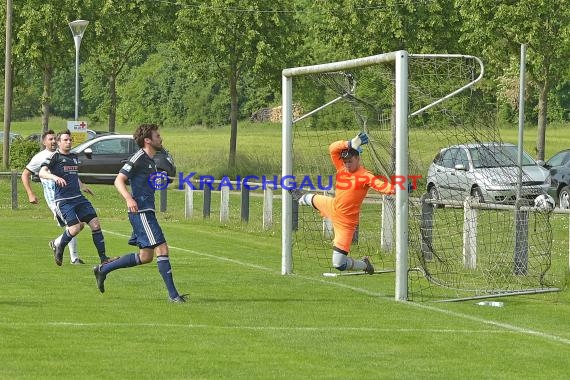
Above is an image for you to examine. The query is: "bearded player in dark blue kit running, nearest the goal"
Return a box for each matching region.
[93,124,186,303]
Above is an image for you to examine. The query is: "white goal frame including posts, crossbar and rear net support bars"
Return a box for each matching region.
[281,50,483,301]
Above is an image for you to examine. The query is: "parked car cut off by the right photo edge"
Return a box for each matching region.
[544,149,570,208]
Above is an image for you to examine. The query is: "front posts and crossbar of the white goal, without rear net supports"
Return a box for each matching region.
[281,50,408,300]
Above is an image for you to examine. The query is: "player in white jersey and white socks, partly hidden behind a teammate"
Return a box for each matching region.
[22,129,85,264]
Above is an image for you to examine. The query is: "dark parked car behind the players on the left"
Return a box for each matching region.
[71,134,176,184]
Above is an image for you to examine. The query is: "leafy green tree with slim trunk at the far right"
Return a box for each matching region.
[457,0,570,160]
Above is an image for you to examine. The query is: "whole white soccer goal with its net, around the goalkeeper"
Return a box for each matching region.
[282,51,561,300]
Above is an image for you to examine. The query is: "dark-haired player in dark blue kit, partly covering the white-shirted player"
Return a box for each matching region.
[39,130,116,266]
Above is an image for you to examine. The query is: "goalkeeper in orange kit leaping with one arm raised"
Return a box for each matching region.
[291,132,395,274]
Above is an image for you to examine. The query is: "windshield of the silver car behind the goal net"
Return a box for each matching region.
[469,145,536,168]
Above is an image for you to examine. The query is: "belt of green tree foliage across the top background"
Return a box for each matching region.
[6,0,570,161]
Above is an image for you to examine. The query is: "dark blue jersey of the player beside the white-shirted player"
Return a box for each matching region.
[42,151,83,202]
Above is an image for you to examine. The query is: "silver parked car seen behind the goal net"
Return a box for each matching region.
[426,142,550,204]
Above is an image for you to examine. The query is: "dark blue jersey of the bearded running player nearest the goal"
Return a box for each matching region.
[119,149,158,212]
